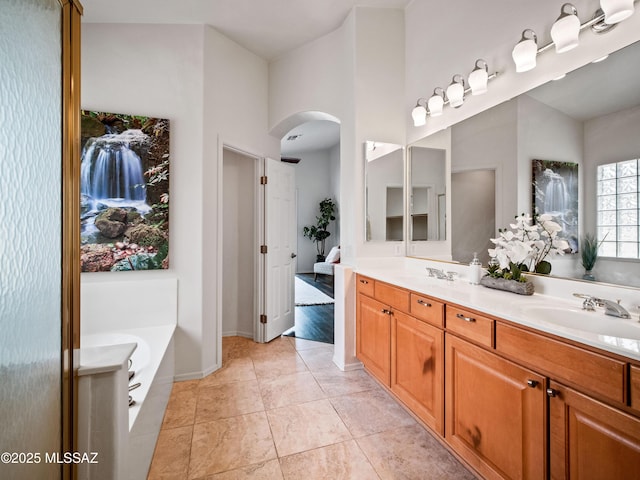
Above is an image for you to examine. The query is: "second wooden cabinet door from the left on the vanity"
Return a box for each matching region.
[391,312,444,435]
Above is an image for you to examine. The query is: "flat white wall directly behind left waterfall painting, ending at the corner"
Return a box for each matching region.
[82,24,204,378]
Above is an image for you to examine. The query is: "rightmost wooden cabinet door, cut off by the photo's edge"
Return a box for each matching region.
[549,382,640,480]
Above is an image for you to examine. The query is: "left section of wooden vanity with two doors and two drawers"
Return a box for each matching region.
[356,275,444,435]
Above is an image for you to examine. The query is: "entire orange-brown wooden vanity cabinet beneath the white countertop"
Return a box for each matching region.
[356,275,640,480]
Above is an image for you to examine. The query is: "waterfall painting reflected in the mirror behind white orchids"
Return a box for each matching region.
[532,160,578,253]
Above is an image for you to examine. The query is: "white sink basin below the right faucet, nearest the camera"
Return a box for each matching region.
[522,306,640,340]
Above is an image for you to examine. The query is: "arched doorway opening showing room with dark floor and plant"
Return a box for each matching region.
[281,116,340,344]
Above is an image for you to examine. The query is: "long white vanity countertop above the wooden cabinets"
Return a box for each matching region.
[356,266,640,360]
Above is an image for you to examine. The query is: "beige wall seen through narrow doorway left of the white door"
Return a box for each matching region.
[222,149,258,338]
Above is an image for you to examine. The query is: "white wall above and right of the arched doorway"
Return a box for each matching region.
[269,7,406,367]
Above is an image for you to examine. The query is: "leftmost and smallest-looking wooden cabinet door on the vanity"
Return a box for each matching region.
[356,294,391,386]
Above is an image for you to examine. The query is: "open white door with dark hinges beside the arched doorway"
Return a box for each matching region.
[260,158,297,342]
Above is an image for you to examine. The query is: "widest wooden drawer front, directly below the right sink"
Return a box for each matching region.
[496,322,626,403]
